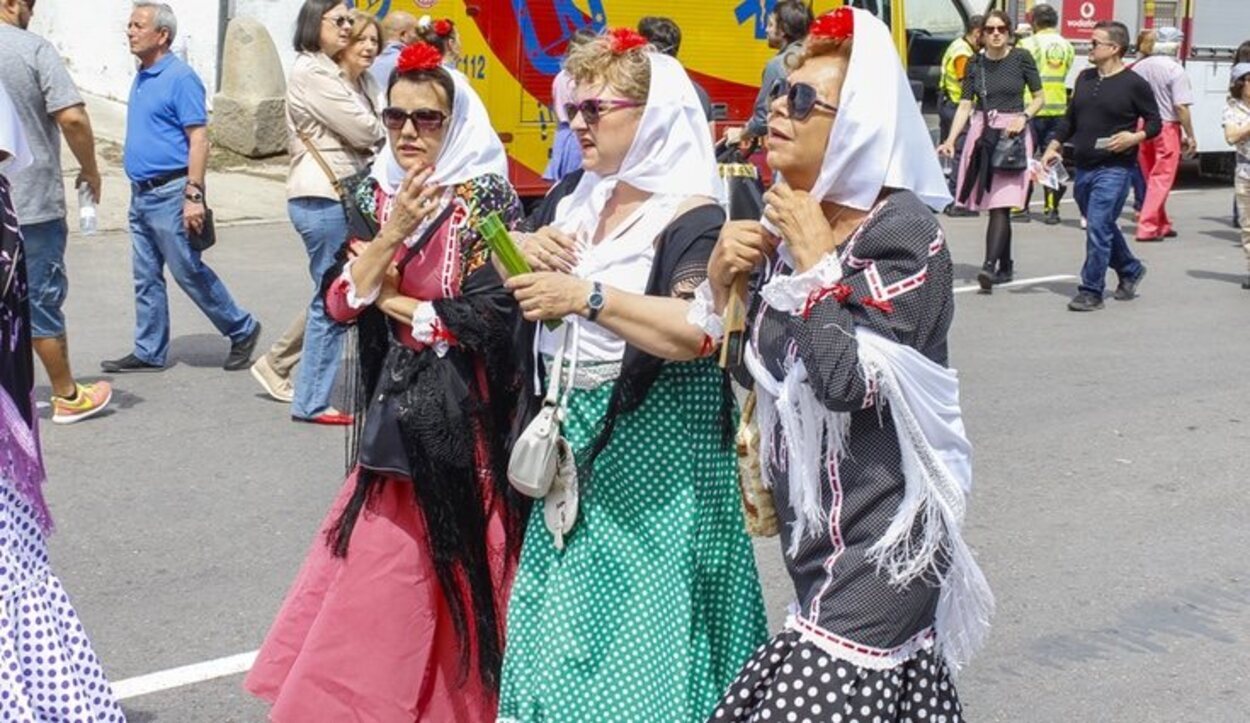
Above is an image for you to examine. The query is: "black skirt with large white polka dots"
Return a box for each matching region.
[709,630,964,723]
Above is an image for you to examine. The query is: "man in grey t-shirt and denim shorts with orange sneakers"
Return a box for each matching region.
[0,0,113,424]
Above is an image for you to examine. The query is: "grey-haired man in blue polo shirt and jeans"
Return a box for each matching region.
[100,3,260,374]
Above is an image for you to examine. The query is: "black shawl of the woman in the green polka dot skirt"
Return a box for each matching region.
[513,171,734,465]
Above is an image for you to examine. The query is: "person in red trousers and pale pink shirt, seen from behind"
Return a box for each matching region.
[1133,28,1198,241]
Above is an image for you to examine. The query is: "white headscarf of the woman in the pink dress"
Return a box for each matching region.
[373,69,508,195]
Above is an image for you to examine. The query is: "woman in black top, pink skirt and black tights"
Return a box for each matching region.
[938,10,1045,294]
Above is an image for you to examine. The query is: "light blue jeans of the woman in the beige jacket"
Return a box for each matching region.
[286,198,348,419]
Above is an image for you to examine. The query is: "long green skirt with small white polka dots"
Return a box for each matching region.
[499,360,768,723]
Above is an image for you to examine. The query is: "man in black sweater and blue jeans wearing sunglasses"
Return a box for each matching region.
[1043,20,1161,311]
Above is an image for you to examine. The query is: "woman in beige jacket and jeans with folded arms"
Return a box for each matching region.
[251,0,385,424]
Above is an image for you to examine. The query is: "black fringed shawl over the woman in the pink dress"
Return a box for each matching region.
[323,170,529,690]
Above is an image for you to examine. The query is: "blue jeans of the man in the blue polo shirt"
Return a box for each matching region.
[130,178,256,367]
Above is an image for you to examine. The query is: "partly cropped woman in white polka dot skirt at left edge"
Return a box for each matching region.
[0,85,126,723]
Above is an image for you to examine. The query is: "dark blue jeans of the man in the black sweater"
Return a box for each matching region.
[1074,166,1143,296]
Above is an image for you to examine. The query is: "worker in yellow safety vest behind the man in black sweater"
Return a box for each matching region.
[1013,4,1076,225]
